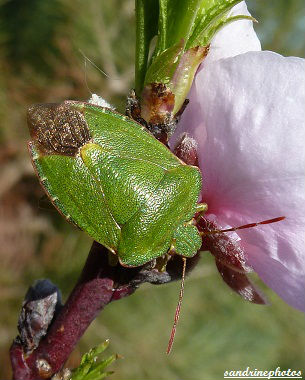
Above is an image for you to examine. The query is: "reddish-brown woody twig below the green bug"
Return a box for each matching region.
[10,243,137,380]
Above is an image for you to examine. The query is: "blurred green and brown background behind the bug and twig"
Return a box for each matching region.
[0,0,305,380]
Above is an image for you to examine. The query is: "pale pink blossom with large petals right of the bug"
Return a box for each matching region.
[172,3,305,311]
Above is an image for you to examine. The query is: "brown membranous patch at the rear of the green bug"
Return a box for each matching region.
[27,103,90,156]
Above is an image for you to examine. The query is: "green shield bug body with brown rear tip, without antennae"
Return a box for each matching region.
[28,101,204,266]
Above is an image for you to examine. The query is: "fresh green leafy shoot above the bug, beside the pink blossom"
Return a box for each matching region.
[136,0,249,108]
